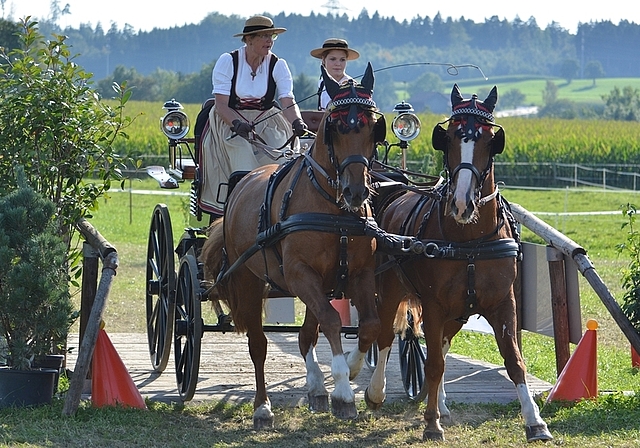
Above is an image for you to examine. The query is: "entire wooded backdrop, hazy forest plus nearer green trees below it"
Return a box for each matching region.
[0,10,640,114]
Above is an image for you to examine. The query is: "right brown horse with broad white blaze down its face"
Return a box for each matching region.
[365,85,552,441]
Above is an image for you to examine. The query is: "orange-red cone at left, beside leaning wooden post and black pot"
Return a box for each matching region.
[91,322,147,409]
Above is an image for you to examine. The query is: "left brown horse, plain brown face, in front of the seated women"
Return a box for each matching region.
[201,64,385,429]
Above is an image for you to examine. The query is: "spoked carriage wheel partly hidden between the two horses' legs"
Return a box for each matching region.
[398,314,427,401]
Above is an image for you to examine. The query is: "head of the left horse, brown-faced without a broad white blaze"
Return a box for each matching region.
[318,63,386,211]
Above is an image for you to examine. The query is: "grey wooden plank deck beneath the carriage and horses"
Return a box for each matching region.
[67,333,552,405]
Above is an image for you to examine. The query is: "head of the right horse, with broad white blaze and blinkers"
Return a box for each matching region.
[432,84,505,224]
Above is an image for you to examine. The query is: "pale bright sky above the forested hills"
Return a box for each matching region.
[5,0,640,34]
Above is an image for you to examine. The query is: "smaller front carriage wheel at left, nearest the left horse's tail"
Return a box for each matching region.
[173,250,202,401]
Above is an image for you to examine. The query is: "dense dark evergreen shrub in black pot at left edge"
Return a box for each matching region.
[0,169,77,407]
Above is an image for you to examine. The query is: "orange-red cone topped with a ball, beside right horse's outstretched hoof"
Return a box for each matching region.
[547,319,598,403]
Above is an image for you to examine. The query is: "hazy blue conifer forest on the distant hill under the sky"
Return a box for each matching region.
[18,10,640,79]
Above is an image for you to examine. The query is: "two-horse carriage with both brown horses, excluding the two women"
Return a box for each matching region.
[146,65,551,440]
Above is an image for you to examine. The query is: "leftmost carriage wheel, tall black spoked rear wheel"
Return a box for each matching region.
[145,204,176,372]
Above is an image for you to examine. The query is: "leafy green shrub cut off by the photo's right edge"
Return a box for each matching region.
[617,203,640,368]
